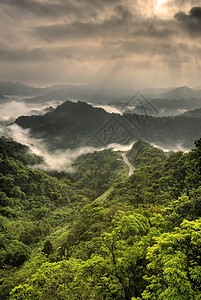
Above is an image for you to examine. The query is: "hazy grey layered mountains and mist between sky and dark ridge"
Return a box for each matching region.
[0,81,201,122]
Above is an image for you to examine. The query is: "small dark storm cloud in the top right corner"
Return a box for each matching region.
[175,6,201,37]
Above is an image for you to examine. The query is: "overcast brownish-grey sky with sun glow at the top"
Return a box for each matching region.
[0,0,201,88]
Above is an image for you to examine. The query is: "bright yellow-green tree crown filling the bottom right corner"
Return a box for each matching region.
[143,219,201,300]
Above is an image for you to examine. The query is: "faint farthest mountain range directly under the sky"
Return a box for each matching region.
[0,81,201,104]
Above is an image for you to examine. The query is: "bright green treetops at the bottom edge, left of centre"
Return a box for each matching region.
[10,260,88,300]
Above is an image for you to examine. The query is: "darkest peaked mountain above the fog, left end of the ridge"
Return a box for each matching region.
[16,101,110,148]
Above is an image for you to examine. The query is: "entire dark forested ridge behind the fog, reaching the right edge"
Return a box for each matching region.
[15,101,201,148]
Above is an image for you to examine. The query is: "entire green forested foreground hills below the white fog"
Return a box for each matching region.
[0,140,201,300]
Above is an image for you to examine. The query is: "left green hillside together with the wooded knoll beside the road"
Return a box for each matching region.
[0,138,126,299]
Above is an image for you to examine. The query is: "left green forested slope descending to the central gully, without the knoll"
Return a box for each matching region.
[0,138,88,299]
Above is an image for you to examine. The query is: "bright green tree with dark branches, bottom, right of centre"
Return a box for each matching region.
[82,212,150,300]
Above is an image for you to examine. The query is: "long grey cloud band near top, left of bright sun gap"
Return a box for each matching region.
[34,5,132,43]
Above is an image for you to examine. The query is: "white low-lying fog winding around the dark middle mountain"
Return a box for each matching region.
[0,99,191,171]
